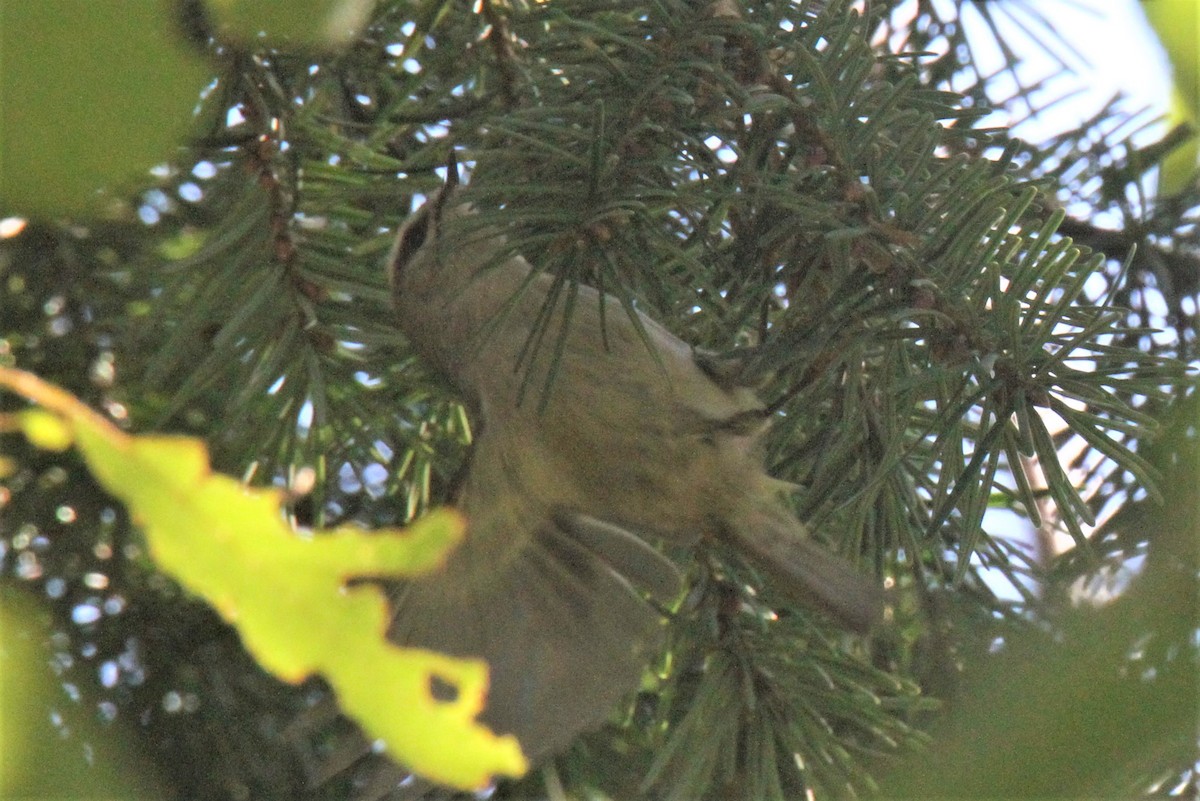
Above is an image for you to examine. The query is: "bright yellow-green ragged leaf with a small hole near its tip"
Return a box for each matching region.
[0,368,527,788]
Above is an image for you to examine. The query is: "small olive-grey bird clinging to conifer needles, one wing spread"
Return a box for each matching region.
[388,170,883,761]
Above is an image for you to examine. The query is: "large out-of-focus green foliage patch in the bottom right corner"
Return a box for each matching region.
[884,383,1200,799]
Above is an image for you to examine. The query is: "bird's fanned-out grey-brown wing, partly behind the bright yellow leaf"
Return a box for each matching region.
[388,514,682,761]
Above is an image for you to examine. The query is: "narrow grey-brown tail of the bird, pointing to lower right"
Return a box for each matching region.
[730,494,884,633]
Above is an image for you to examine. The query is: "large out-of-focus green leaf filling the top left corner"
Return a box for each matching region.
[0,0,212,217]
